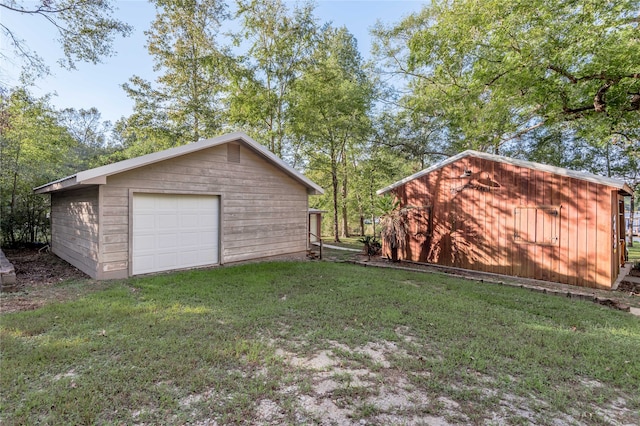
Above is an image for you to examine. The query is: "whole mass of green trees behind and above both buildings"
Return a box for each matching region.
[0,0,640,246]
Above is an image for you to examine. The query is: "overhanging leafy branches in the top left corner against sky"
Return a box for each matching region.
[0,0,131,74]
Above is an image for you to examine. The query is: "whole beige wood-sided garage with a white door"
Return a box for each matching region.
[34,133,323,279]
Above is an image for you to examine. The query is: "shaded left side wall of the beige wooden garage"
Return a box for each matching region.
[51,186,99,278]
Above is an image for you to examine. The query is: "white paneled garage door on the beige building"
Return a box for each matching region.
[131,194,220,275]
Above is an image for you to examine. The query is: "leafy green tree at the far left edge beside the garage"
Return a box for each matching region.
[0,88,77,245]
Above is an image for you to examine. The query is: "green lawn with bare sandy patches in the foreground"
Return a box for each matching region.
[0,262,640,425]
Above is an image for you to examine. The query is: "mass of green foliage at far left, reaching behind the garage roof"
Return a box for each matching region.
[0,88,114,245]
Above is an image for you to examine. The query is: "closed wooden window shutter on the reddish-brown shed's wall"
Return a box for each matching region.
[513,206,560,245]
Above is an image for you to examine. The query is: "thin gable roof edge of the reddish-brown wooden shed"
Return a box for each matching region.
[377,150,633,195]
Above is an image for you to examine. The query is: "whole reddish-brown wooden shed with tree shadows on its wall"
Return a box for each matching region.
[378,151,632,289]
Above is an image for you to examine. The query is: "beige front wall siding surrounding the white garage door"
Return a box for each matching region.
[101,145,308,277]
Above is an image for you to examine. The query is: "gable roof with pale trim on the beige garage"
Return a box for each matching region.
[33,132,324,195]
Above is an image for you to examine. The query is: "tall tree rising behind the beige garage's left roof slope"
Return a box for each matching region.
[123,0,230,145]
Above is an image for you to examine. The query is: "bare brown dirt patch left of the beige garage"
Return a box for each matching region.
[0,249,98,313]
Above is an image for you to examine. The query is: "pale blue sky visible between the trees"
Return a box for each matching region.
[0,0,428,122]
